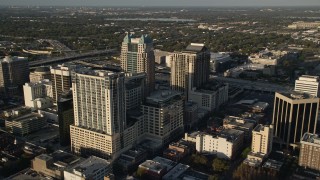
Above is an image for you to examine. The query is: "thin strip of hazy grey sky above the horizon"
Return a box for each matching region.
[0,0,320,7]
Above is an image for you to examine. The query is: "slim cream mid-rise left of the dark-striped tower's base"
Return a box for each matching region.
[246,124,273,165]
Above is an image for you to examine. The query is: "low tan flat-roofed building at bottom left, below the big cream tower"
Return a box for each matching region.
[31,150,82,180]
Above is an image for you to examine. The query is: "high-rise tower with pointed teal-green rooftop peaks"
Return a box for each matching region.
[121,34,155,94]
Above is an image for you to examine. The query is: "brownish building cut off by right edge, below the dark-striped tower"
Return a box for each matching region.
[299,133,320,171]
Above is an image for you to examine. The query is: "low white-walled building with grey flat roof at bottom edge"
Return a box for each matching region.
[64,156,112,180]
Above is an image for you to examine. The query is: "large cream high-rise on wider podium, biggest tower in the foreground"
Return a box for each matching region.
[70,69,126,158]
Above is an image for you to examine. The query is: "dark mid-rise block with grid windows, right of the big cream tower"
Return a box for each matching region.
[142,90,184,144]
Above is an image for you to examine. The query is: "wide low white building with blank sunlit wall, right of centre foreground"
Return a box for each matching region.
[196,129,244,159]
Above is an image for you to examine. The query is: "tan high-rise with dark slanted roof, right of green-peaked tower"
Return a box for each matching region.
[170,43,210,97]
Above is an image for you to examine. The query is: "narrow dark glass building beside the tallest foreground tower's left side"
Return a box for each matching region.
[57,91,74,146]
